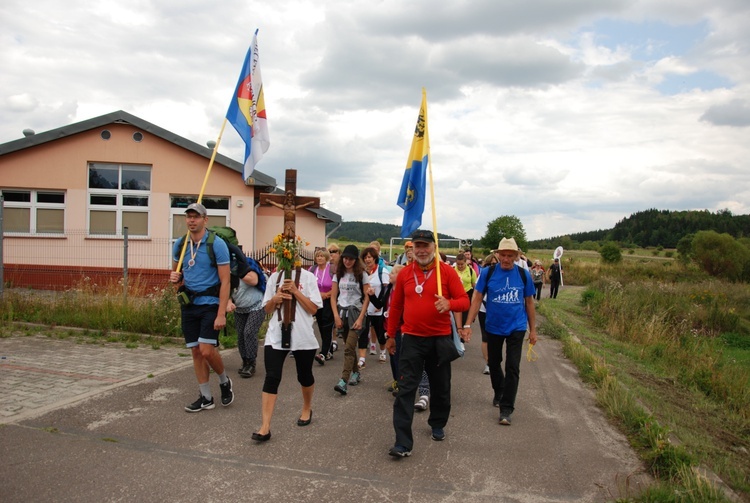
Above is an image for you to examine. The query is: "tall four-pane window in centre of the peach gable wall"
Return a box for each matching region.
[88,162,151,237]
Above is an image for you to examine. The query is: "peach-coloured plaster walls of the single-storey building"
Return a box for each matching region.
[0,123,325,288]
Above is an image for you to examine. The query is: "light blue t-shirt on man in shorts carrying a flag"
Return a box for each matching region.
[172,231,229,306]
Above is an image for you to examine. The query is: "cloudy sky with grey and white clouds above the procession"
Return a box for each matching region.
[0,0,750,239]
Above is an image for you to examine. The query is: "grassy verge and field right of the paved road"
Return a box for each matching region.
[540,280,750,501]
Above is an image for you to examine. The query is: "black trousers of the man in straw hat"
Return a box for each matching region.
[487,330,526,414]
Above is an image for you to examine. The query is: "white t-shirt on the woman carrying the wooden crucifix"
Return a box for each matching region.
[263,269,323,351]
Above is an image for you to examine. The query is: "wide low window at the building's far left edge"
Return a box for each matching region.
[2,189,65,235]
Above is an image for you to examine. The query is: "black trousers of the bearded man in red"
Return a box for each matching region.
[393,334,452,450]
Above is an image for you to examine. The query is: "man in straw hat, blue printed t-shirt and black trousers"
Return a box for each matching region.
[461,238,537,426]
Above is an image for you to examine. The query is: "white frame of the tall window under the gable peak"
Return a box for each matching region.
[86,162,153,239]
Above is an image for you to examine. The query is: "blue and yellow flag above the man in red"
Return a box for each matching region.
[396,89,430,238]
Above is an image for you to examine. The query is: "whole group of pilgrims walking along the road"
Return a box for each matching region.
[170,203,562,458]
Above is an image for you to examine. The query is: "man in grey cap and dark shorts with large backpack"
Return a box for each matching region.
[169,203,234,412]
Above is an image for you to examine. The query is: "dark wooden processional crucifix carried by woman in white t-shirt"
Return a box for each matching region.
[260,169,320,348]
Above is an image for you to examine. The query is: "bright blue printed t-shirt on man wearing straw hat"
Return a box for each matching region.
[476,265,535,336]
